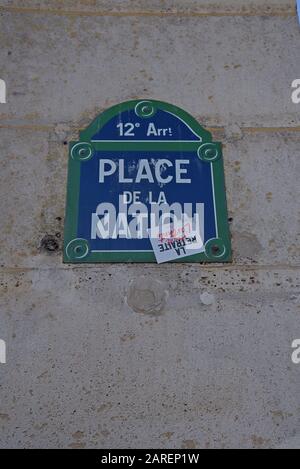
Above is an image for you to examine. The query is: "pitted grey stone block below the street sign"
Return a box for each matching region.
[0,265,300,447]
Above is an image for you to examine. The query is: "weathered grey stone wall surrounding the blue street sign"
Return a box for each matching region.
[0,0,300,448]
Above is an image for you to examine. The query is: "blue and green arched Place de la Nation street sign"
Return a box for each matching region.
[64,100,231,263]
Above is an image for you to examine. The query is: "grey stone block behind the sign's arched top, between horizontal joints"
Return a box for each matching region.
[0,12,300,127]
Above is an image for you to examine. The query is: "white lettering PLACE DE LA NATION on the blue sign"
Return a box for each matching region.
[91,158,204,239]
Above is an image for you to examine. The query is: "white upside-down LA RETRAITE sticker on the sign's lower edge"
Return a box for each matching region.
[148,221,204,264]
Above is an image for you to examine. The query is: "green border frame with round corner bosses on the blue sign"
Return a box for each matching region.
[63,99,232,264]
